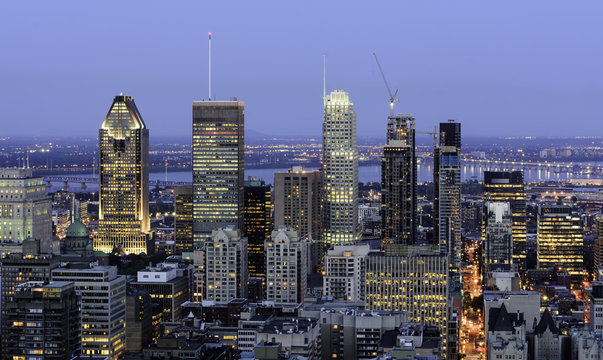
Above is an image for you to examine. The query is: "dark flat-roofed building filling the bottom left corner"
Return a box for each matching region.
[2,281,81,360]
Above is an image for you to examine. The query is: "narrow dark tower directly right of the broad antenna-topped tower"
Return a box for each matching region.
[243,178,272,279]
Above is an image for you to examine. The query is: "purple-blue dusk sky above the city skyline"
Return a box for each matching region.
[0,0,603,137]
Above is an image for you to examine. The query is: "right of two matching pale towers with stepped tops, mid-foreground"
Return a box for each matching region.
[264,227,308,304]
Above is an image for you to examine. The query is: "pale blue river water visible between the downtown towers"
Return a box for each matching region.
[51,161,596,191]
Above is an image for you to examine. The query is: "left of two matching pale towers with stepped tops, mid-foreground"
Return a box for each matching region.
[203,227,248,303]
